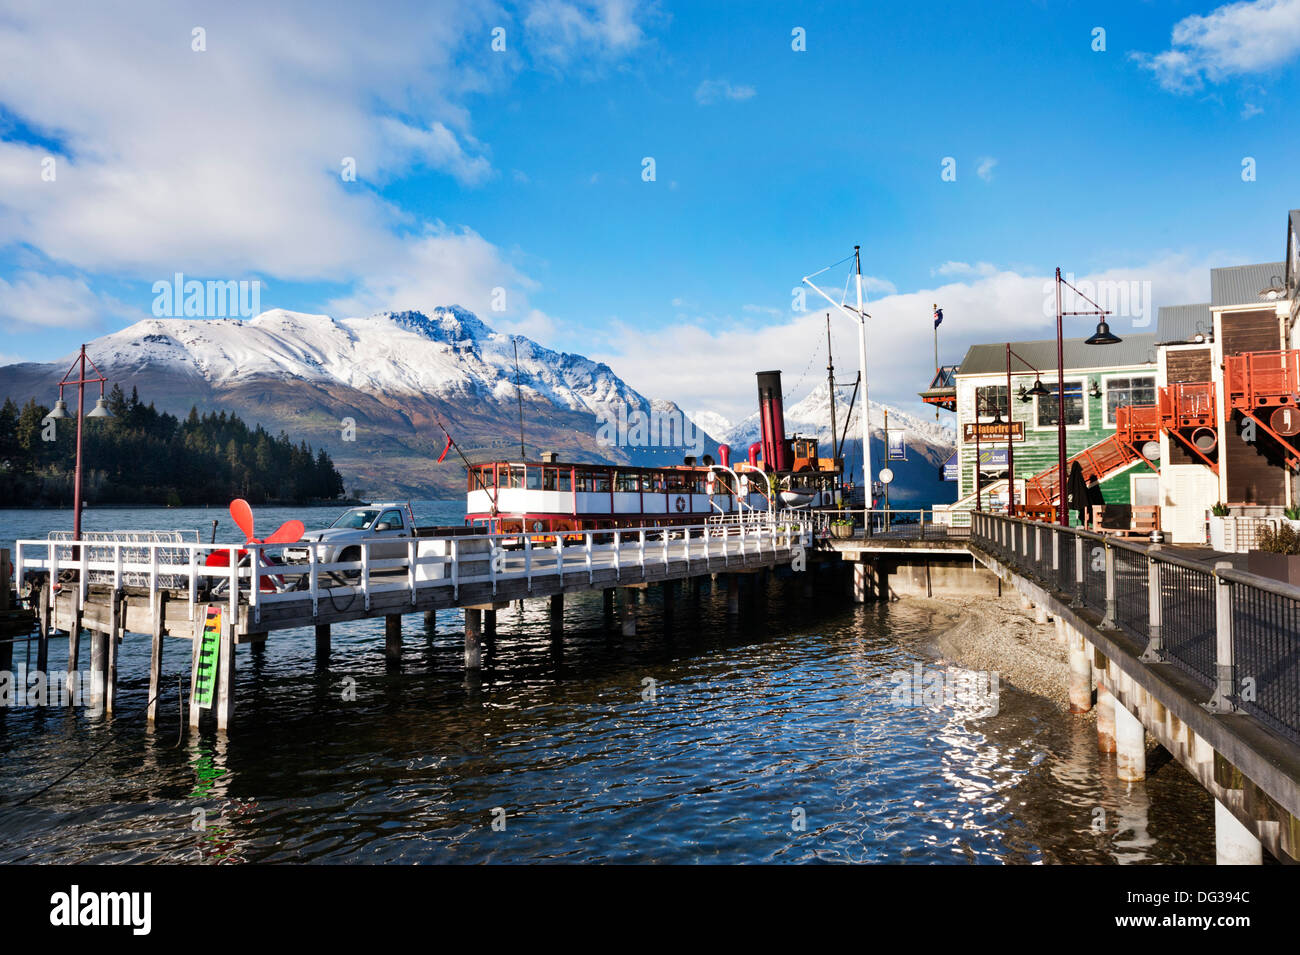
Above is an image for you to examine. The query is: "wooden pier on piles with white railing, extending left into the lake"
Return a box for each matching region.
[16,516,813,732]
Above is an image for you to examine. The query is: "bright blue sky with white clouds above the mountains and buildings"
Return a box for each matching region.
[0,0,1300,417]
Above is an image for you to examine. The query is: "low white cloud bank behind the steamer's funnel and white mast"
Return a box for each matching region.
[592,256,1227,420]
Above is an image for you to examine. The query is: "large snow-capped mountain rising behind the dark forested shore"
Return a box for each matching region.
[0,307,716,496]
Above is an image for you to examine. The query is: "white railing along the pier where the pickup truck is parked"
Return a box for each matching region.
[14,515,813,625]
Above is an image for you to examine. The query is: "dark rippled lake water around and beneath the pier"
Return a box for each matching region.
[0,503,1214,864]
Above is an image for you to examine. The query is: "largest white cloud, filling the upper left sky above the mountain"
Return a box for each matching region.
[0,0,655,325]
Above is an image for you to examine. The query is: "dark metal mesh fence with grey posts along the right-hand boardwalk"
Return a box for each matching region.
[970,513,1300,741]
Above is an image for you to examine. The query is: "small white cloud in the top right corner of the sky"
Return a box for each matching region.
[1130,0,1300,92]
